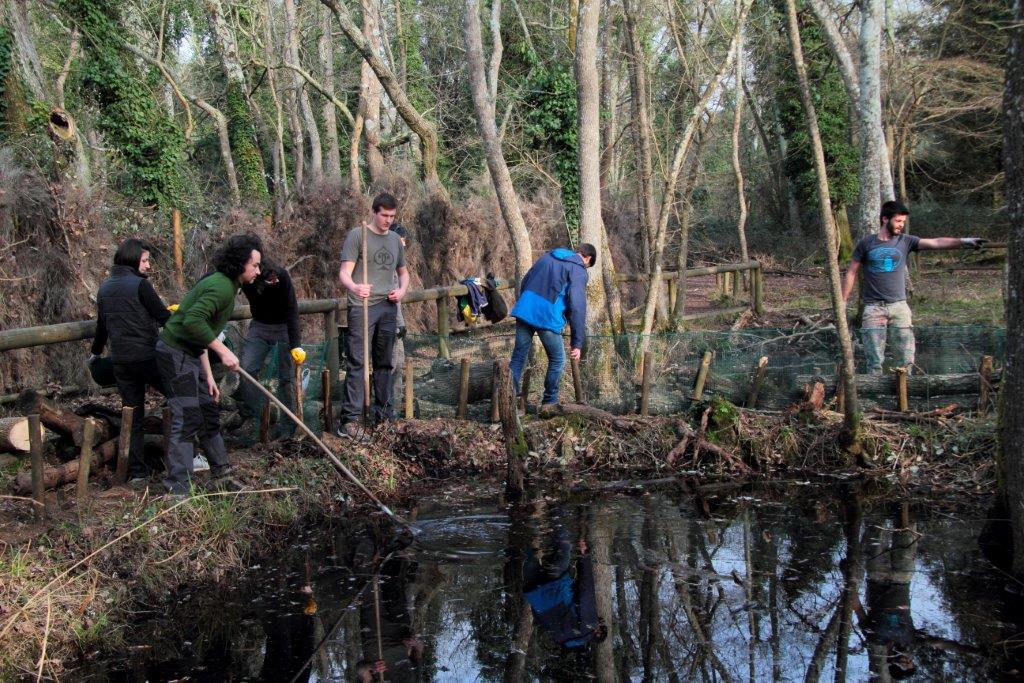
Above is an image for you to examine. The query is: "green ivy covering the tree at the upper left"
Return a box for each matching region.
[60,0,185,206]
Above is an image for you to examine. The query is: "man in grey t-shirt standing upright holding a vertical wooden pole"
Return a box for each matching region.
[338,193,409,438]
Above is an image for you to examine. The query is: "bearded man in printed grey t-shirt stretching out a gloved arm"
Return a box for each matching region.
[843,202,985,374]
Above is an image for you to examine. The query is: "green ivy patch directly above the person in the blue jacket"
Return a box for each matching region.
[523,63,580,245]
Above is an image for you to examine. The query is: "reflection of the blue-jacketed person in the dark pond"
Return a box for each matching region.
[522,511,608,649]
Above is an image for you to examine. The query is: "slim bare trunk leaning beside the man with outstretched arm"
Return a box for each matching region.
[785,0,860,453]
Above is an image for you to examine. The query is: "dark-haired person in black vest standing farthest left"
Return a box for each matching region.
[89,238,171,483]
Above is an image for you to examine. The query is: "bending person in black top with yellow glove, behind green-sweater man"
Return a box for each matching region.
[232,259,306,436]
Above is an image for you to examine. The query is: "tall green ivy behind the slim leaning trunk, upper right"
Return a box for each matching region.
[777,3,860,209]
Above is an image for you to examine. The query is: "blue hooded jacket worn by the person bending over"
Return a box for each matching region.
[512,249,587,348]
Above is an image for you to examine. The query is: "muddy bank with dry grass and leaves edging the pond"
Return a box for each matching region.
[0,402,994,677]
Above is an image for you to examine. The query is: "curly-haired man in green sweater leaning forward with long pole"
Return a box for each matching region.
[157,234,263,495]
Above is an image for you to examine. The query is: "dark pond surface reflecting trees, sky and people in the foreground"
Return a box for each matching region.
[90,485,1017,681]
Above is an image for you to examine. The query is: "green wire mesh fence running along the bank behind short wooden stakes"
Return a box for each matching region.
[222,325,1006,429]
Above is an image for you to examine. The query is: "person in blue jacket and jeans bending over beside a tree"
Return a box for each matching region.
[509,243,597,404]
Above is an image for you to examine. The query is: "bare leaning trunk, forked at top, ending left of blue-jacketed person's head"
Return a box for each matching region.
[464,0,534,288]
